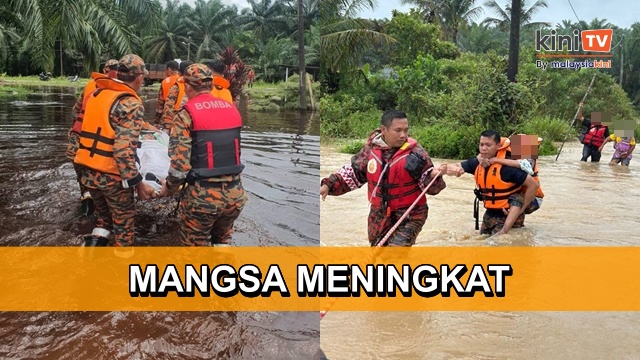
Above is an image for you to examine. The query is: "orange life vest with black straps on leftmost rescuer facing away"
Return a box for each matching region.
[73,78,142,175]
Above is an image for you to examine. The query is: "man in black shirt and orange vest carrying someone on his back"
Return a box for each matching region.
[449,130,539,235]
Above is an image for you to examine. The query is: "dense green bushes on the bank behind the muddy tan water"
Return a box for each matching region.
[321,35,638,159]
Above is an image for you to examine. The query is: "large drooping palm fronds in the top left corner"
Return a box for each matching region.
[10,0,159,71]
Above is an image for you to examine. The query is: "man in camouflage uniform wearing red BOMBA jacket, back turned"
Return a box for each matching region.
[160,64,247,246]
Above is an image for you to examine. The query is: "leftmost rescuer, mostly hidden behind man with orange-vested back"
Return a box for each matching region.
[65,59,118,216]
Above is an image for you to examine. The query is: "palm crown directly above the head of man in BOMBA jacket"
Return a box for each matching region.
[185,0,237,59]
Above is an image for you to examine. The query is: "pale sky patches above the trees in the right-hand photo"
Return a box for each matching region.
[360,0,640,28]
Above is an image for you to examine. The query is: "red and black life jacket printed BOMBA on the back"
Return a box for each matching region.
[184,92,244,180]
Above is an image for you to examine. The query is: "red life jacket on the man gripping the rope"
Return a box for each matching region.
[367,138,427,211]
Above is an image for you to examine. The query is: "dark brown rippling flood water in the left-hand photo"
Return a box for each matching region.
[0,87,320,359]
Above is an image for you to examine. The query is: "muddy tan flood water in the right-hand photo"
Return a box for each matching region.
[320,142,640,359]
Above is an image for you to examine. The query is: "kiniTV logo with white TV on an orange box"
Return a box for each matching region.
[536,29,613,53]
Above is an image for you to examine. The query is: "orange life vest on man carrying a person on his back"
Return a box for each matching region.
[474,137,522,209]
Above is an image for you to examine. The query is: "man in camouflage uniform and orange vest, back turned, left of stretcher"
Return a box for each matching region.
[74,54,154,246]
